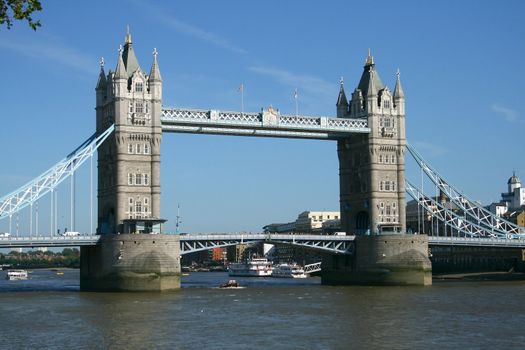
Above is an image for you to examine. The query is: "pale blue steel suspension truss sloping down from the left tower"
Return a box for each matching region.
[0,125,115,219]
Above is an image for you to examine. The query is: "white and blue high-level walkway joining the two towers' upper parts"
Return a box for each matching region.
[161,108,370,140]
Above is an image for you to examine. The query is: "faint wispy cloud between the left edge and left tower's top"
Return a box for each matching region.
[0,38,97,76]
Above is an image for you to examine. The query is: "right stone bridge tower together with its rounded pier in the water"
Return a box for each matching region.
[322,53,432,285]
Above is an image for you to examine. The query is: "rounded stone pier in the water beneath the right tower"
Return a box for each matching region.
[321,234,432,286]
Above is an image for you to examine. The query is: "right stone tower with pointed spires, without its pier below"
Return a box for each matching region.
[337,53,406,235]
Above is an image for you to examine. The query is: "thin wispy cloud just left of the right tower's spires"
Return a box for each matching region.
[249,66,335,96]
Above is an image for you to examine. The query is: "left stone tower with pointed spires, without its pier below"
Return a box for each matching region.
[96,32,163,234]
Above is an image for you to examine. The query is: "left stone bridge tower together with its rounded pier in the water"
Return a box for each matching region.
[80,31,180,291]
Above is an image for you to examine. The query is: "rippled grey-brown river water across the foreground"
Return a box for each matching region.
[0,270,525,349]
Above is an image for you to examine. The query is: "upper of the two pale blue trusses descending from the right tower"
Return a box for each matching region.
[406,144,524,236]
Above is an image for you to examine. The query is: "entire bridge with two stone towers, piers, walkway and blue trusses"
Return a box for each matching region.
[0,33,524,290]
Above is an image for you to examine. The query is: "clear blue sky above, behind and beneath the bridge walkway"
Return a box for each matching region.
[0,0,525,232]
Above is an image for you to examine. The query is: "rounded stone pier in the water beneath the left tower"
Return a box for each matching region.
[80,234,181,291]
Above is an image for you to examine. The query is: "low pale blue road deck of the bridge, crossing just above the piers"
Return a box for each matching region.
[0,233,525,254]
